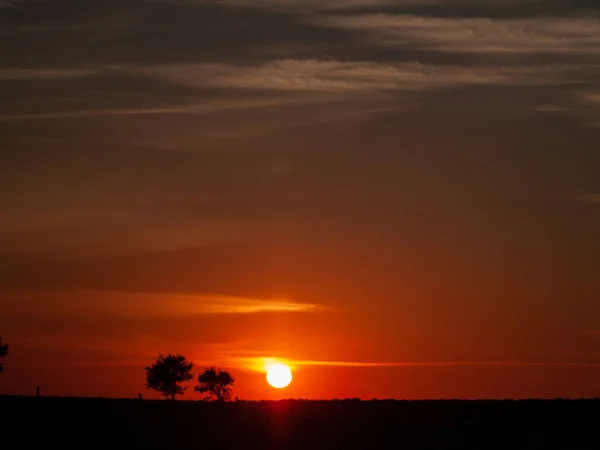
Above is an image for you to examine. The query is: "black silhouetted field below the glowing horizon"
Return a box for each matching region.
[0,397,600,450]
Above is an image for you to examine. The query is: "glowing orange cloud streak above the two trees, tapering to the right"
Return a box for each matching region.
[0,290,317,318]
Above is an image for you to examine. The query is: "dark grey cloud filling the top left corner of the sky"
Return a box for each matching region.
[0,0,350,67]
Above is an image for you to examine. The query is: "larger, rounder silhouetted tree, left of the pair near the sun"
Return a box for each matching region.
[145,353,194,400]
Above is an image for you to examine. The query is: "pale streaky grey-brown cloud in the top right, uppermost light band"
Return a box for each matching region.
[308,13,600,55]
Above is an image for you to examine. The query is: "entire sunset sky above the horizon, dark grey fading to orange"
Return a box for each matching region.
[0,0,600,399]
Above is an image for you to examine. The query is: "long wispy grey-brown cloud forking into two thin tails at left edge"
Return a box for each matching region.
[0,59,573,122]
